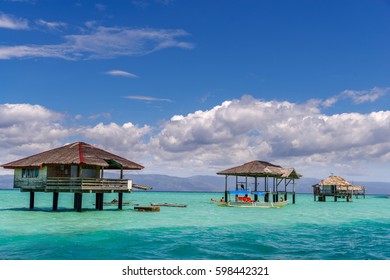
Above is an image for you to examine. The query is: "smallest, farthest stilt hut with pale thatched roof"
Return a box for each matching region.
[313,175,366,202]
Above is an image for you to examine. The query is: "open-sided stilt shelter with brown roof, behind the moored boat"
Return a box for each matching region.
[217,160,301,204]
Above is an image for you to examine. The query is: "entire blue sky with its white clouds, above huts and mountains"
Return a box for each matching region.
[0,0,390,181]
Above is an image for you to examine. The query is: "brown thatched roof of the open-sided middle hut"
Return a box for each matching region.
[217,160,302,179]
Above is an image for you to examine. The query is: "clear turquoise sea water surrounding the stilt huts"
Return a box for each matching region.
[0,190,390,260]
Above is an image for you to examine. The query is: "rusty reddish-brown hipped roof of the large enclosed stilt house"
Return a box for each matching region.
[1,142,144,170]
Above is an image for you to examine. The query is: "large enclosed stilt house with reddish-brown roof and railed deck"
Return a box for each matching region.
[1,142,149,212]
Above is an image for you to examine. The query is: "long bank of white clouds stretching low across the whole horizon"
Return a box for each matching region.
[0,92,390,182]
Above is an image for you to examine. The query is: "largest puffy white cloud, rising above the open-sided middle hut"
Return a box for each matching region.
[151,96,390,176]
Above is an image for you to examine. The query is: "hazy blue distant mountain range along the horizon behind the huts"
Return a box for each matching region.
[0,174,390,194]
